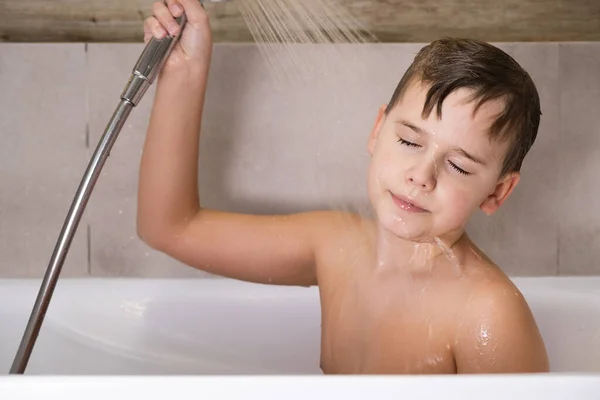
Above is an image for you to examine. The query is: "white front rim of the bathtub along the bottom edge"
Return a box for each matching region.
[0,373,600,400]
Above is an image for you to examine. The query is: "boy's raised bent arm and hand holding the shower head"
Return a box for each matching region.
[137,0,330,286]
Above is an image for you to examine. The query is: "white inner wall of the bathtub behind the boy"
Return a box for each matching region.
[0,277,600,375]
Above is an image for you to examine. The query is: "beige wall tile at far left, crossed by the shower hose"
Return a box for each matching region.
[0,43,88,278]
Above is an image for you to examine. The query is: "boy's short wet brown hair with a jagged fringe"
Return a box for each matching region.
[385,38,542,177]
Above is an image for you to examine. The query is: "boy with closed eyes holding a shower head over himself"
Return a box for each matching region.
[137,0,549,374]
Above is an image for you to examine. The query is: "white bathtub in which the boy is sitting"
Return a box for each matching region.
[0,277,600,399]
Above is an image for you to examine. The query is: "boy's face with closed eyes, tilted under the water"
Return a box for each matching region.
[368,84,519,242]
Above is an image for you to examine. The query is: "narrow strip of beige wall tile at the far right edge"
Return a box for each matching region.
[555,43,600,275]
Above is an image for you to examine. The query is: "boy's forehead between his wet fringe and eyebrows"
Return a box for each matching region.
[394,83,507,153]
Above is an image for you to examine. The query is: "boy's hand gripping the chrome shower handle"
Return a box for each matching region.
[144,0,212,69]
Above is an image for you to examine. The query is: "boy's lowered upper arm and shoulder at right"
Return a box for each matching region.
[454,262,549,373]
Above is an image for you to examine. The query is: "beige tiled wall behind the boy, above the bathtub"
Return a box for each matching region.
[0,43,600,277]
